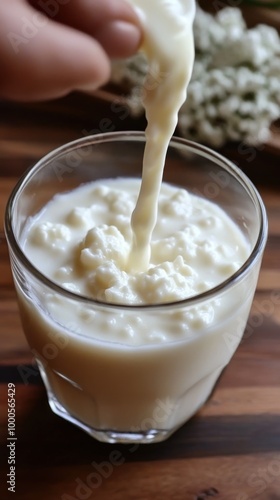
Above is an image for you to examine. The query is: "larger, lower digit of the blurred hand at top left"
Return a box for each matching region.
[0,1,110,101]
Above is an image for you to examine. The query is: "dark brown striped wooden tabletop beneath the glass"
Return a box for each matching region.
[0,95,280,500]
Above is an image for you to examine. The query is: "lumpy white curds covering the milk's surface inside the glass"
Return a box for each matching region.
[23,178,249,312]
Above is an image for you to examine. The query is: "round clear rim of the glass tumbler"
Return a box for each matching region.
[4,131,268,311]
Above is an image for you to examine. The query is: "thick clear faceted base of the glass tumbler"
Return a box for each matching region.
[37,359,225,444]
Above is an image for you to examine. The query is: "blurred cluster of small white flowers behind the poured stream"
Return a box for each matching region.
[113,7,280,147]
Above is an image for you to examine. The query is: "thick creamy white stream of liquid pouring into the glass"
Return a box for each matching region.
[127,0,195,271]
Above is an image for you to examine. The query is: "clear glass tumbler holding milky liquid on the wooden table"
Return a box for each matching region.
[5,132,267,443]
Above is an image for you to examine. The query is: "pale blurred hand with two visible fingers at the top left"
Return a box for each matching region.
[0,0,141,101]
